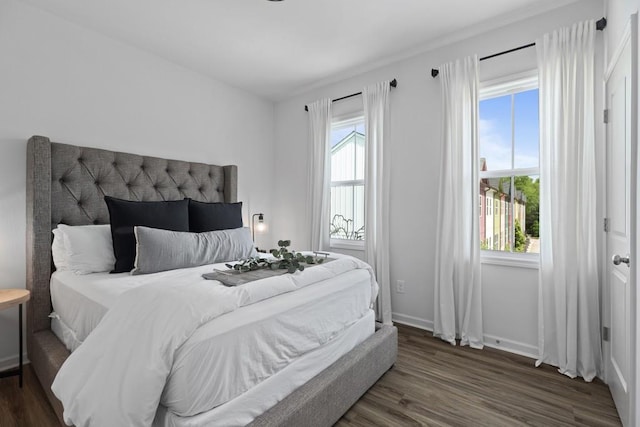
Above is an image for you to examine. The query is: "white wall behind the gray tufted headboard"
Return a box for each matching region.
[0,0,274,369]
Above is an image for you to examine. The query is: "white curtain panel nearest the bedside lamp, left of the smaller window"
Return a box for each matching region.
[307,98,331,251]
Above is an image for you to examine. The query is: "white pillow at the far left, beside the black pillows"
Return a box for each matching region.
[51,224,116,274]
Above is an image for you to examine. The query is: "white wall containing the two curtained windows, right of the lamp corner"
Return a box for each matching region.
[272,0,604,355]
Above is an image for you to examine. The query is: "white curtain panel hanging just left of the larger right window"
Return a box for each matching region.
[433,56,483,348]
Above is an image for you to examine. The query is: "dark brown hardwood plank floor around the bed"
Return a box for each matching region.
[0,325,620,427]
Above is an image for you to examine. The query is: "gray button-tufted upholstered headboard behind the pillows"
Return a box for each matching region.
[27,136,238,333]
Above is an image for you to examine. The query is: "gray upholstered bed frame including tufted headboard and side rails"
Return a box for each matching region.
[26,136,397,426]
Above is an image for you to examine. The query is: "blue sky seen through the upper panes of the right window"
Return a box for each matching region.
[479,89,539,170]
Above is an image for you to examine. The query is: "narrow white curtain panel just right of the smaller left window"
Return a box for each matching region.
[362,81,391,325]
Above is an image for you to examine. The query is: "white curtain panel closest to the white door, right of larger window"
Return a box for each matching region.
[536,21,602,381]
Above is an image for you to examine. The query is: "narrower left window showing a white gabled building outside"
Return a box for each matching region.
[329,117,365,246]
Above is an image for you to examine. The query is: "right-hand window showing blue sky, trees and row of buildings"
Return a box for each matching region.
[478,76,540,253]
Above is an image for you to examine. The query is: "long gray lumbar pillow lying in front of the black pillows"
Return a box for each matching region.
[131,226,257,274]
